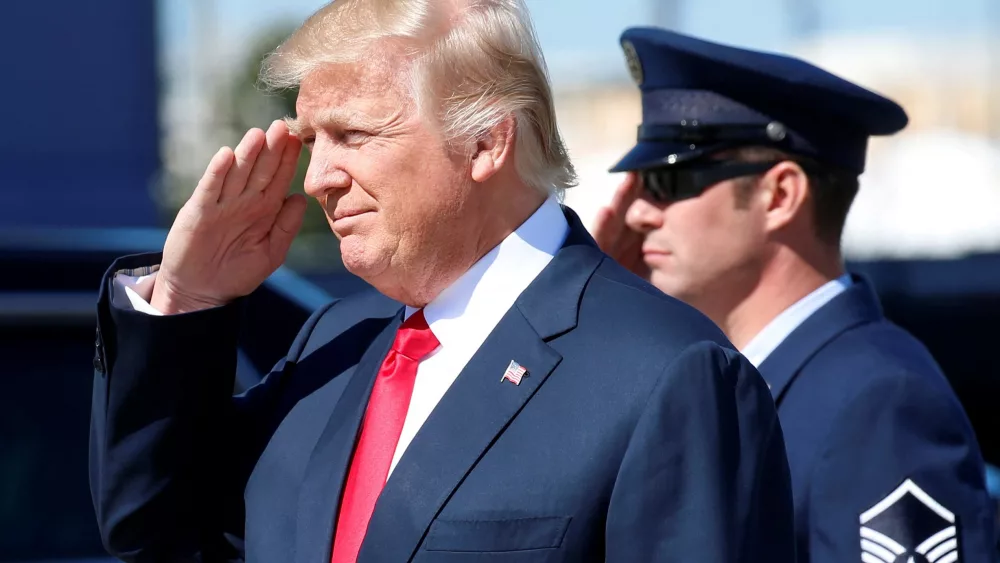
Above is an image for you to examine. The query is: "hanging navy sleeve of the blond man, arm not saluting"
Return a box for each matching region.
[606,343,795,563]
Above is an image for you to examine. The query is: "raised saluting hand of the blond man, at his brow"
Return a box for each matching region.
[150,121,306,314]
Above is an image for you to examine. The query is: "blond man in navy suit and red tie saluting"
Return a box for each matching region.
[91,1,794,563]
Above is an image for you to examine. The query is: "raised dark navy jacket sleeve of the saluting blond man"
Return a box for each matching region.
[90,254,336,561]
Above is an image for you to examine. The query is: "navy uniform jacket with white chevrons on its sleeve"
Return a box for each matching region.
[760,276,997,563]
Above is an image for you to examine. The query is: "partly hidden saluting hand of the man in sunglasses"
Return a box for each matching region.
[594,172,650,280]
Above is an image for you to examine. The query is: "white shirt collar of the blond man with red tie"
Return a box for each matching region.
[406,197,569,348]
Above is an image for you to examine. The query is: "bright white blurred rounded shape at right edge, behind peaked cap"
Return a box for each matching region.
[844,130,1000,259]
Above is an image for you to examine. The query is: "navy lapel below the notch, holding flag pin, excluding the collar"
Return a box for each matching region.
[358,309,562,563]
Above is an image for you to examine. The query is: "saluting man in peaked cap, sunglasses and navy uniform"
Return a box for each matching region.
[595,28,996,563]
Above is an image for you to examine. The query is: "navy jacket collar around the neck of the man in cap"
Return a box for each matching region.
[760,276,882,406]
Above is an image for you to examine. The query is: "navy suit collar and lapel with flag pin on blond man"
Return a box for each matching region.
[358,210,604,563]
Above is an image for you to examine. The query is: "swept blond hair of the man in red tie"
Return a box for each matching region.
[261,0,576,193]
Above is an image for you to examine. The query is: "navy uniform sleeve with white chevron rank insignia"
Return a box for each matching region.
[808,373,1000,563]
